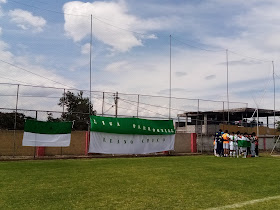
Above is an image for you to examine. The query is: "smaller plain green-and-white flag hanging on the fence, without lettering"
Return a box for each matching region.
[22,120,72,147]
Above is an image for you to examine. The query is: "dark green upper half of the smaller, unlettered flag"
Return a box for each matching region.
[24,120,72,134]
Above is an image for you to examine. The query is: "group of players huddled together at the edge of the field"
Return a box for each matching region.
[214,129,259,158]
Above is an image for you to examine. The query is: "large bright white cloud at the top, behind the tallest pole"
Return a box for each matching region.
[63,1,170,52]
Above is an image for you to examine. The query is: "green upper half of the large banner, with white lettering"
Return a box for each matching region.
[90,116,175,135]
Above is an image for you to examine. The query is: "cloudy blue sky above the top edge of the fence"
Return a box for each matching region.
[0,0,280,116]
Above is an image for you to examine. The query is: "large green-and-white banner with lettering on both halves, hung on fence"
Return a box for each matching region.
[89,116,175,154]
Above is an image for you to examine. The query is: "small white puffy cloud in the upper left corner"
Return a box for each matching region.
[9,9,47,32]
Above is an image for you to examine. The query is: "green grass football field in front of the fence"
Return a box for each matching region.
[0,156,280,209]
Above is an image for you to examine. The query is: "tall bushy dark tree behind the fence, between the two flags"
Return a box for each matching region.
[58,91,95,130]
